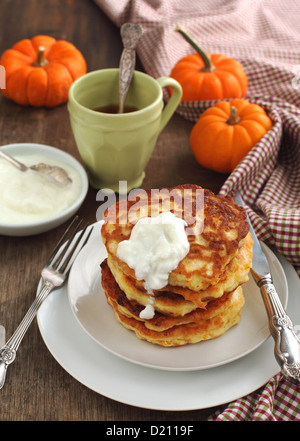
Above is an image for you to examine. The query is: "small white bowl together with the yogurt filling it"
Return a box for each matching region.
[0,143,88,236]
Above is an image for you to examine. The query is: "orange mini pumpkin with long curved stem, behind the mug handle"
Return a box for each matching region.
[170,27,248,101]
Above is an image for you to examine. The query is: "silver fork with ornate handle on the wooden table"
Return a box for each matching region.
[0,216,92,389]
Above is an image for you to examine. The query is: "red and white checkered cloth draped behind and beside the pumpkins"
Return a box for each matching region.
[95,0,300,420]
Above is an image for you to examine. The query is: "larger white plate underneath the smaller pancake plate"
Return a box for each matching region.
[37,220,300,411]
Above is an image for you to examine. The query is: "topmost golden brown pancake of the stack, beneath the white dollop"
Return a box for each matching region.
[101,185,249,291]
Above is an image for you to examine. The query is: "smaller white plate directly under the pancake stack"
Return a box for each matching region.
[68,224,288,371]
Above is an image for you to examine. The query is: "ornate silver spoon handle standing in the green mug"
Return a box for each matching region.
[118,23,143,113]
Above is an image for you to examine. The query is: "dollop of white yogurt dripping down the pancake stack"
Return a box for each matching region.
[117,212,190,319]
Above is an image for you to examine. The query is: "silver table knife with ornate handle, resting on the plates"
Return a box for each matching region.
[235,191,300,386]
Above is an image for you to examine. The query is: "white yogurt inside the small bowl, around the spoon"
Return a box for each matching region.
[0,155,82,224]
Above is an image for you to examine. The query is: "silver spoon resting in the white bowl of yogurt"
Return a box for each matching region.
[0,149,72,187]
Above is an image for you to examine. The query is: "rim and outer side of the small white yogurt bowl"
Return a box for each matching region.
[0,143,89,236]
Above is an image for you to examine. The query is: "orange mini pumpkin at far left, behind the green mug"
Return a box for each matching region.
[0,35,87,107]
